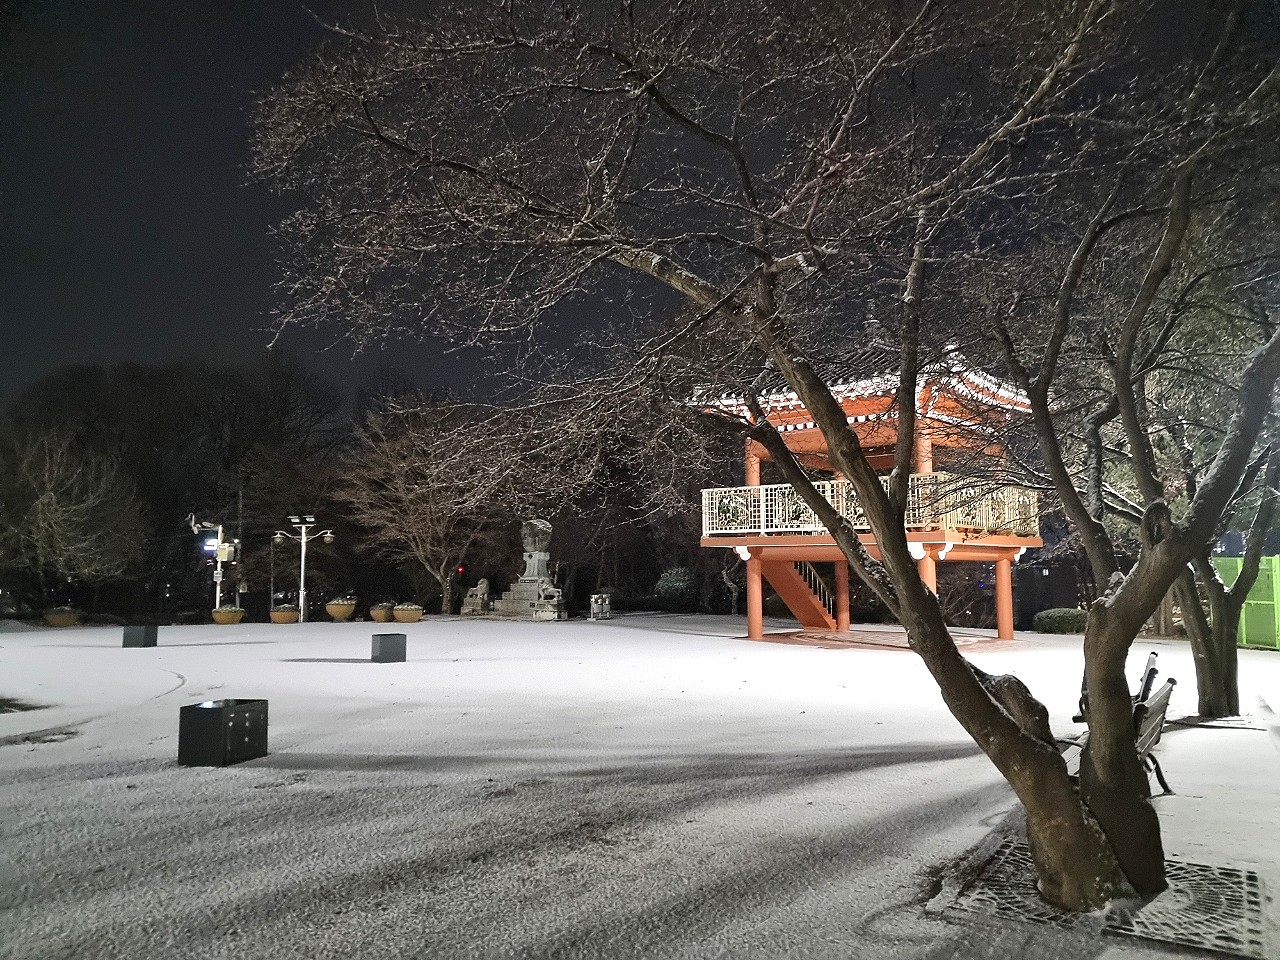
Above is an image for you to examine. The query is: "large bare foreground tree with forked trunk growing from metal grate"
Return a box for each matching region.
[256,0,1280,910]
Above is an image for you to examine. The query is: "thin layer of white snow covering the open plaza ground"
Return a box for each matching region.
[0,614,1280,960]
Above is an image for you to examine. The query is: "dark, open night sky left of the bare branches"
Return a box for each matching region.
[0,0,484,402]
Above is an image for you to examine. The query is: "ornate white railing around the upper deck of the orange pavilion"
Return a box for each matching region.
[703,474,1039,536]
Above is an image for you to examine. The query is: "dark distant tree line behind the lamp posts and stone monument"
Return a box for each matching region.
[0,355,742,621]
